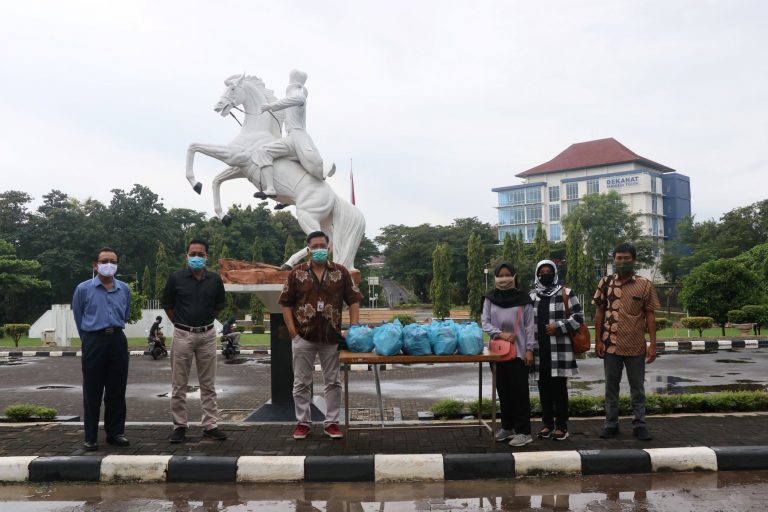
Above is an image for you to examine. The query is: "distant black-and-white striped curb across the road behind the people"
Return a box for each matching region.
[0,339,768,360]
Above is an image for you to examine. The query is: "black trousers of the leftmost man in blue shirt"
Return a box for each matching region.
[81,331,128,443]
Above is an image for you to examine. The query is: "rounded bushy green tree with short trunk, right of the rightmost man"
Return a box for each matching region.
[680,259,758,336]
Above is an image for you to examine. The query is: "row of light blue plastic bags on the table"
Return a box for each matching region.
[347,319,483,356]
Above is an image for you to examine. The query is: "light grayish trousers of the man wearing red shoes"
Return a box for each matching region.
[292,336,341,426]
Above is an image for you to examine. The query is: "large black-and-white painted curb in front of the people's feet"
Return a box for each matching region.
[0,446,768,483]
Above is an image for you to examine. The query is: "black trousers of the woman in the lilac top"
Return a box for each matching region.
[496,358,531,435]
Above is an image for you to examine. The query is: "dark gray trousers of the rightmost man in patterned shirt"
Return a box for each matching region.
[603,354,645,428]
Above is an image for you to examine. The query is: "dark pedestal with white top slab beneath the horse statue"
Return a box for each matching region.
[224,283,325,422]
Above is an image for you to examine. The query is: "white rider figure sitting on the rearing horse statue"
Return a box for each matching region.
[250,69,336,199]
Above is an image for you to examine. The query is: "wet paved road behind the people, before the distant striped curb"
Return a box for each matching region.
[0,349,768,421]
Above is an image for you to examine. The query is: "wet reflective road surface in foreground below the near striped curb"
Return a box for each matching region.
[0,471,768,512]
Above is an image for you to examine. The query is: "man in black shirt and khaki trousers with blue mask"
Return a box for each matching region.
[161,240,227,443]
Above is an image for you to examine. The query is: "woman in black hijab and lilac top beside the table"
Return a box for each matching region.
[481,262,535,446]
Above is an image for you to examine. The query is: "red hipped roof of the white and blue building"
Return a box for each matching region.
[516,137,676,178]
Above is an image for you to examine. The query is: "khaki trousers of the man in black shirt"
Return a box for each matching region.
[171,329,219,430]
